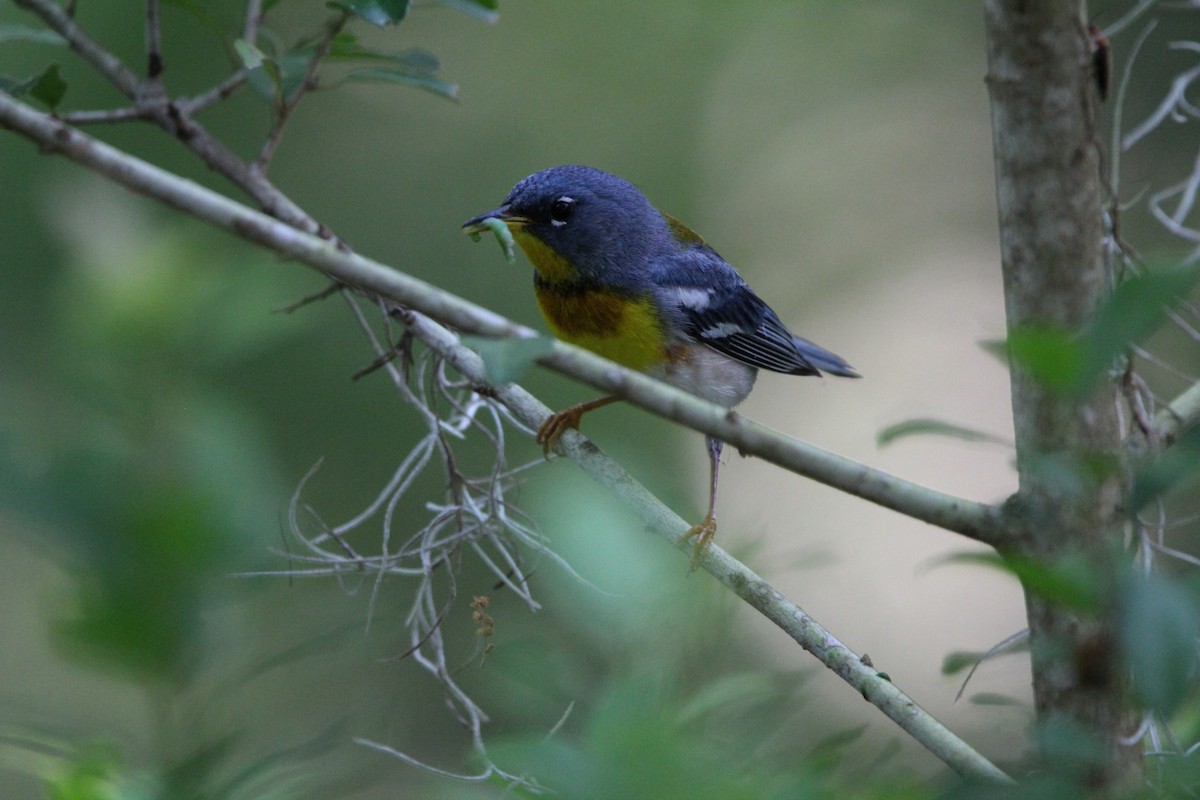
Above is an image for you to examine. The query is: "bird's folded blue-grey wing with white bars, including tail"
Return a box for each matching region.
[654,246,858,378]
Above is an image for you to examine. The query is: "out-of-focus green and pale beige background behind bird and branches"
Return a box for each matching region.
[0,0,1200,799]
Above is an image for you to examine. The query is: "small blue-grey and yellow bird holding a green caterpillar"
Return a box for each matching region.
[462,167,859,566]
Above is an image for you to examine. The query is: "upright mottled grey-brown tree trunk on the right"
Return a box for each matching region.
[985,0,1141,789]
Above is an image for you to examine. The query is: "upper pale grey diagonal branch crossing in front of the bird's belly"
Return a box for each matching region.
[0,95,1007,546]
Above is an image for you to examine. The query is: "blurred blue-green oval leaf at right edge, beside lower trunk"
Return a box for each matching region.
[1118,576,1200,718]
